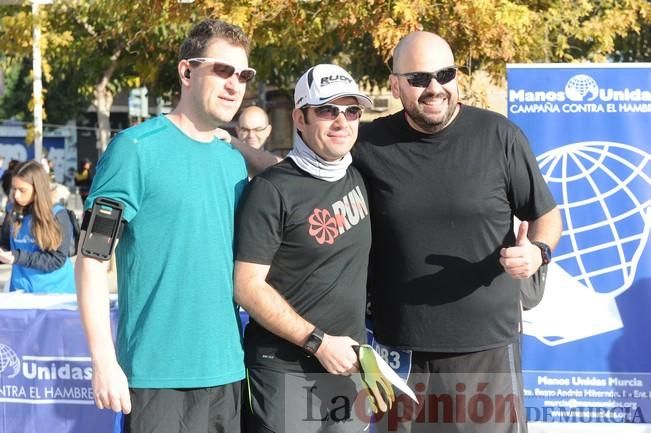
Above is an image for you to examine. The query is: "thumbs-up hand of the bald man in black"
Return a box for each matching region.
[500,221,542,279]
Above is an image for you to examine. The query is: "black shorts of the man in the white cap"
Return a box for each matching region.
[243,368,371,433]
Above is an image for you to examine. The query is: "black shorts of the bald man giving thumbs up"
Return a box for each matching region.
[375,343,527,433]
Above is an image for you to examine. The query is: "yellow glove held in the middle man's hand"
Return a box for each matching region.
[355,344,396,413]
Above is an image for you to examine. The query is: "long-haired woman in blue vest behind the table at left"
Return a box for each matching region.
[0,161,75,293]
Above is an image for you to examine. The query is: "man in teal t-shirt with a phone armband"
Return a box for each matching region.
[76,20,255,433]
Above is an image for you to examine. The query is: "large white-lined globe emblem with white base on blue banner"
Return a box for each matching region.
[523,141,651,346]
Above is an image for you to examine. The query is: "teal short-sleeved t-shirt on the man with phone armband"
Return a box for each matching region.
[86,116,247,388]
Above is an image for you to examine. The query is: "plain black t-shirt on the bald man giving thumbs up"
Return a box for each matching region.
[353,106,555,352]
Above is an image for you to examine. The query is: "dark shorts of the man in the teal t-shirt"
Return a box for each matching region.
[122,381,242,433]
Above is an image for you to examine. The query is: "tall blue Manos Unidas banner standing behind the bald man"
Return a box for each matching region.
[507,64,651,433]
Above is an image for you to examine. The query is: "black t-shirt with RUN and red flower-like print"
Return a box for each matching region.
[236,158,371,371]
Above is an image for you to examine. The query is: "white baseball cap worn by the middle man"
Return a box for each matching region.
[294,64,373,108]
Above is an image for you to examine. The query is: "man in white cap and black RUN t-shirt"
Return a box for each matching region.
[235,64,371,433]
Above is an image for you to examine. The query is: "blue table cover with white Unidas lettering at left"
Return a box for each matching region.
[0,294,117,433]
